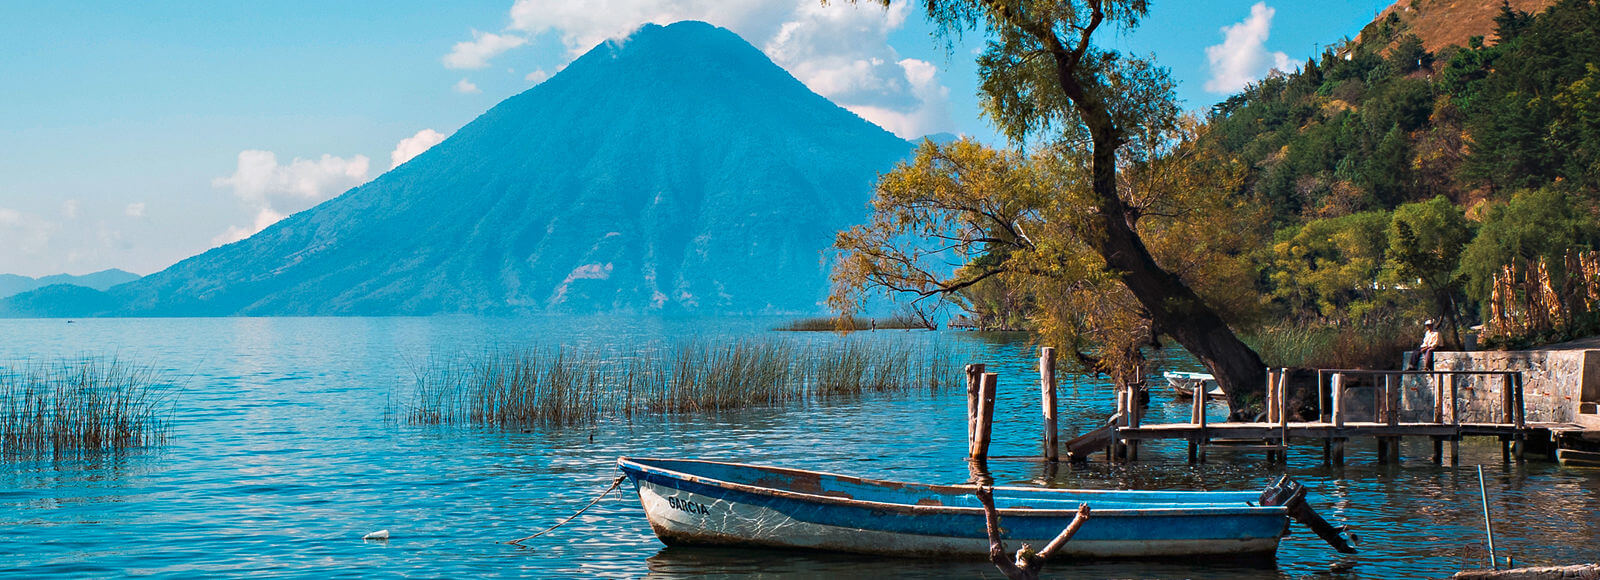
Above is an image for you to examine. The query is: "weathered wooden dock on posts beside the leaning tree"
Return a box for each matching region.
[966,354,1600,465]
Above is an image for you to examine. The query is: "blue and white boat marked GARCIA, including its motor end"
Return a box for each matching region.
[618,457,1342,559]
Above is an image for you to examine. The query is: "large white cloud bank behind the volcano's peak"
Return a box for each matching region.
[510,0,954,138]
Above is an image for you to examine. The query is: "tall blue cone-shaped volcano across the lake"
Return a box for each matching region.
[0,22,912,316]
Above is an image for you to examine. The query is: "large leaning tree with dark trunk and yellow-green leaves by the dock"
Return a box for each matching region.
[834,0,1266,410]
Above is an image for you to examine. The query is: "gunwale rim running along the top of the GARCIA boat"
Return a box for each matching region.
[618,457,1288,518]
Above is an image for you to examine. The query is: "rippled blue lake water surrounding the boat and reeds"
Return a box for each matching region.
[0,317,1600,578]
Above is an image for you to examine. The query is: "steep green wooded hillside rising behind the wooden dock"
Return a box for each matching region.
[1205,0,1600,349]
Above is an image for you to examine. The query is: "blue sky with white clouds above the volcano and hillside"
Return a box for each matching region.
[0,0,1387,276]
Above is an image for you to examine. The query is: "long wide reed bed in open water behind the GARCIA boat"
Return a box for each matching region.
[397,338,965,426]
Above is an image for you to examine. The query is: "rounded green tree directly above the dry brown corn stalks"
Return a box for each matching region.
[1461,187,1600,301]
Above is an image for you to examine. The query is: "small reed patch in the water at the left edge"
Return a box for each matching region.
[0,359,173,458]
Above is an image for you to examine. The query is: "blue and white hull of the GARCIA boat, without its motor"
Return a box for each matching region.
[622,463,1286,559]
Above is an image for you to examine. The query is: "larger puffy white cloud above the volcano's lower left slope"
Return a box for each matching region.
[211,149,371,244]
